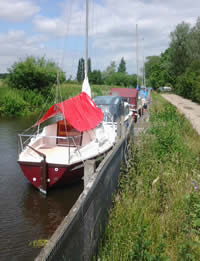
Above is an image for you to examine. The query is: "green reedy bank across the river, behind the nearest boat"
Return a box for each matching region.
[0,81,111,118]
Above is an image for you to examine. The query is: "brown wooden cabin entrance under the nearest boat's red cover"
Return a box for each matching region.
[57,120,83,147]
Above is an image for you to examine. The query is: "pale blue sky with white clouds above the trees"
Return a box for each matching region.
[0,0,200,78]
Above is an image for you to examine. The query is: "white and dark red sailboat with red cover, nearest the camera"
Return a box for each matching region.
[18,0,116,194]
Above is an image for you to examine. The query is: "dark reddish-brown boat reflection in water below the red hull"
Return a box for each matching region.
[23,182,83,235]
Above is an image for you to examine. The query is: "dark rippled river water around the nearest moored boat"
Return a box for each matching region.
[0,119,83,261]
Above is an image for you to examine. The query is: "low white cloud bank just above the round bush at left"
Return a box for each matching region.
[0,30,80,77]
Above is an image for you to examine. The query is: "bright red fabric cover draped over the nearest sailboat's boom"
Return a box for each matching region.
[34,92,103,131]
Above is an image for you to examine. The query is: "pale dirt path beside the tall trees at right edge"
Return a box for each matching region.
[162,94,200,135]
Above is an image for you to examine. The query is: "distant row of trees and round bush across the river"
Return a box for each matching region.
[0,56,137,94]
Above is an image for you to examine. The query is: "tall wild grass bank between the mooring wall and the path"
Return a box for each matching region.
[98,94,200,261]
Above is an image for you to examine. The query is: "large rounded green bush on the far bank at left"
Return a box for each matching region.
[7,56,65,93]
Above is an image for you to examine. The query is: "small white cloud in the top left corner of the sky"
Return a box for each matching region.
[0,0,40,22]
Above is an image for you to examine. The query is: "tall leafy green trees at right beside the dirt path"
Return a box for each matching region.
[145,17,200,103]
